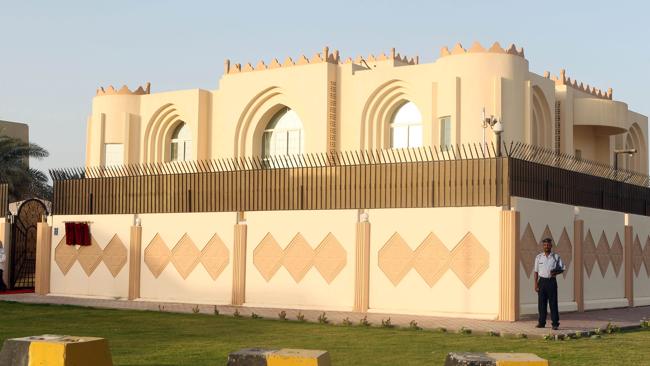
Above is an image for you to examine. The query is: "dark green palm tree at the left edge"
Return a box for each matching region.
[0,135,52,202]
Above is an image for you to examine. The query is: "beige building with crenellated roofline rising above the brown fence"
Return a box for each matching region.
[86,43,648,173]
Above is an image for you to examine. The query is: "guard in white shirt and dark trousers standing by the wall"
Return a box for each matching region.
[535,238,564,330]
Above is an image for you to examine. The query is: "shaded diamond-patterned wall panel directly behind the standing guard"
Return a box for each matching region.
[512,197,578,314]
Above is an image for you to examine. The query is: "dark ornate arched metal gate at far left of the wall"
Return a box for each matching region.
[9,198,47,288]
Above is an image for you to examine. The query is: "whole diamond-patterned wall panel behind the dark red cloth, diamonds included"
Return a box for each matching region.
[50,215,133,298]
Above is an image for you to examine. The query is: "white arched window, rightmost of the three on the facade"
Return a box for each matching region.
[390,102,422,148]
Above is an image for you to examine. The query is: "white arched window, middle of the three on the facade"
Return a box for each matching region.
[262,107,303,158]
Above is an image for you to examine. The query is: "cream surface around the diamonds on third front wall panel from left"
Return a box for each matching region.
[245,210,357,311]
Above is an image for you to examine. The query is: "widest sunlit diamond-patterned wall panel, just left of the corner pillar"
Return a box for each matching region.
[368,207,501,318]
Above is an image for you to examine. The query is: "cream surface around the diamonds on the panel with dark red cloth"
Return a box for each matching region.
[50,215,133,298]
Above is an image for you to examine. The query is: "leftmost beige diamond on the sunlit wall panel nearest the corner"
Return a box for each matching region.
[378,233,413,286]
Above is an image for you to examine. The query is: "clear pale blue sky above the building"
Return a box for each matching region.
[0,0,650,174]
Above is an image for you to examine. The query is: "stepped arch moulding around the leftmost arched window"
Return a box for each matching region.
[142,103,187,163]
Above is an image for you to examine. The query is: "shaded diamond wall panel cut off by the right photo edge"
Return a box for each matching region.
[629,215,650,306]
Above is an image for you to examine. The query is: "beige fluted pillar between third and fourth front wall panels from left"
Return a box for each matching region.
[354,222,370,312]
